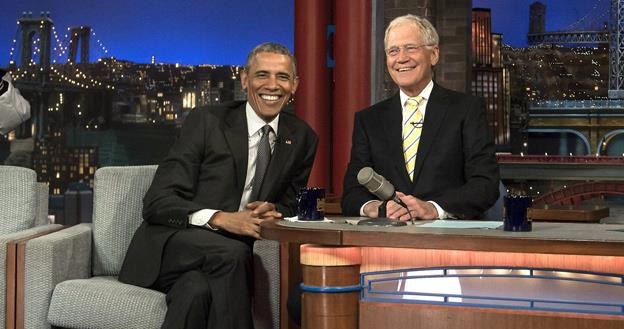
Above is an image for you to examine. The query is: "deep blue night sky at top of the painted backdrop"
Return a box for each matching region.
[0,0,609,66]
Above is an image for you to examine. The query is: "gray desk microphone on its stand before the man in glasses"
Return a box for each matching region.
[357,167,414,226]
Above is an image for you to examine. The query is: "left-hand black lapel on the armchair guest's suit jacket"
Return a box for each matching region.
[223,103,249,195]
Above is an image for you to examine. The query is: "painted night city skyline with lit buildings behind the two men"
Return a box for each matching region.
[0,0,622,194]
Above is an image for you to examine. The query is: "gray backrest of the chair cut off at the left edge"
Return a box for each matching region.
[0,166,38,234]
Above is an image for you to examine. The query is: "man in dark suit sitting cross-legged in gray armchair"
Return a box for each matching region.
[119,43,317,329]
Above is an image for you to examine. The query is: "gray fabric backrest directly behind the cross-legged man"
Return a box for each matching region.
[93,165,157,276]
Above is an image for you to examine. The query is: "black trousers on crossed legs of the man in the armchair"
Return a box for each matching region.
[152,228,253,329]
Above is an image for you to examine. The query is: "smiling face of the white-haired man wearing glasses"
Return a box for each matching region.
[386,22,439,96]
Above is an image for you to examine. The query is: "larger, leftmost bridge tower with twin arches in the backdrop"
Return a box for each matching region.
[18,12,54,68]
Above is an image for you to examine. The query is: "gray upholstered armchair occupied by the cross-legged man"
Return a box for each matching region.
[24,166,279,329]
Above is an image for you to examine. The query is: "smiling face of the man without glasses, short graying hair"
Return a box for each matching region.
[241,52,299,122]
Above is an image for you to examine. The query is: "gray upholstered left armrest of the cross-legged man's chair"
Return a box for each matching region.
[23,223,93,328]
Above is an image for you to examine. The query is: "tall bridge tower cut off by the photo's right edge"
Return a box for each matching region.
[609,0,624,99]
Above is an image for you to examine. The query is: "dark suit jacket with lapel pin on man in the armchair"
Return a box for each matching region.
[119,102,318,287]
